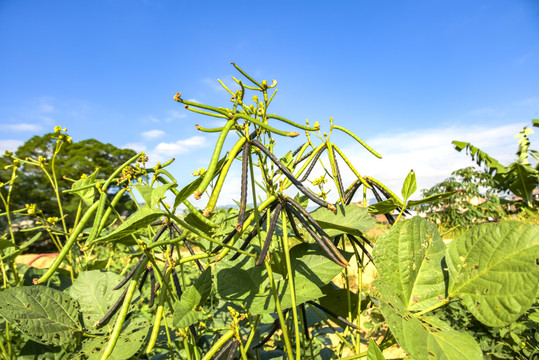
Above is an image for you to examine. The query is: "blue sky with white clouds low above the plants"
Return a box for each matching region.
[0,0,539,204]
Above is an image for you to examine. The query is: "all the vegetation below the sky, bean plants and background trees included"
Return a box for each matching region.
[0,64,539,360]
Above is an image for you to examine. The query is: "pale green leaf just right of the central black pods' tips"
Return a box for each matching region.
[311,205,375,237]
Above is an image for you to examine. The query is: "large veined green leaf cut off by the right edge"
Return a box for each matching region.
[446,221,539,326]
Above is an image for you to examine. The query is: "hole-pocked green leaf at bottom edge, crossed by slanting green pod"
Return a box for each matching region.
[76,317,150,360]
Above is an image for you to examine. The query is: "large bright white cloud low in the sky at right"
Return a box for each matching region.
[340,123,533,198]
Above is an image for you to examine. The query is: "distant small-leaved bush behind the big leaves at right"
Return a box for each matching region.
[418,167,505,229]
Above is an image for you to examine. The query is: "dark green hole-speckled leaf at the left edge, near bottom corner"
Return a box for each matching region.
[0,286,82,345]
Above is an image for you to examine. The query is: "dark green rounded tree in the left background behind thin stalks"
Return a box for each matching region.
[0,128,136,248]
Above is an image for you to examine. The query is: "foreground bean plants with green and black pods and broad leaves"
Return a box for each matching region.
[0,65,539,360]
